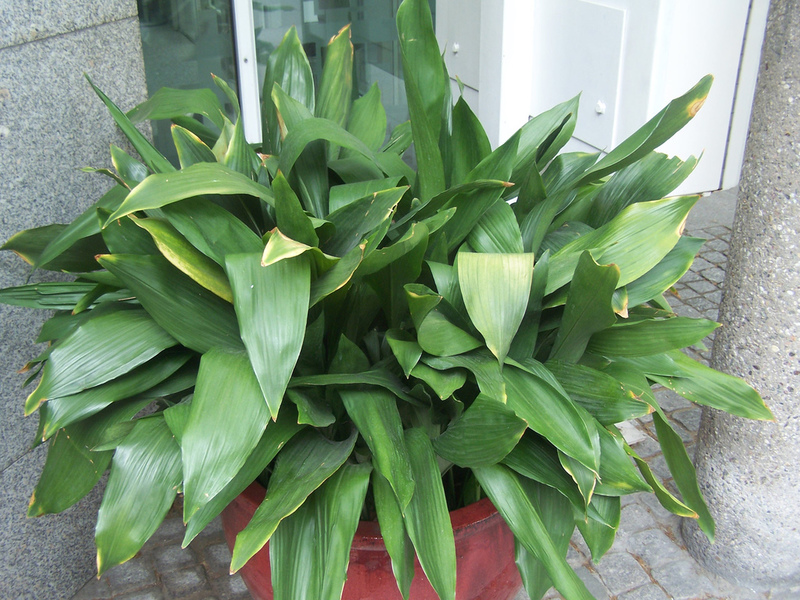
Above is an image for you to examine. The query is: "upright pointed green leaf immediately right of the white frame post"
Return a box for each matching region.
[261,26,315,153]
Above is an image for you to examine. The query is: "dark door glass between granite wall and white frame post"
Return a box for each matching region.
[137,0,237,164]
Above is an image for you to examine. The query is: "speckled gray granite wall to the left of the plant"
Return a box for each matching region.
[0,0,151,600]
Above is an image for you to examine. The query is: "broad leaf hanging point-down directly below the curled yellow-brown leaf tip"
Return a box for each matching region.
[225,253,311,419]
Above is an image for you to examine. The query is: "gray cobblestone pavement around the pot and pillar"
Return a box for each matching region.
[72,192,770,600]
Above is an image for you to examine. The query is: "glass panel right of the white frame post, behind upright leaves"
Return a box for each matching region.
[253,0,435,136]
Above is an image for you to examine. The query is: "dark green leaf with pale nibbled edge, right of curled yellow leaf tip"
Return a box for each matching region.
[322,187,408,256]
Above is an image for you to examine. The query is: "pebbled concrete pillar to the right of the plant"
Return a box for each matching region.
[683,0,800,597]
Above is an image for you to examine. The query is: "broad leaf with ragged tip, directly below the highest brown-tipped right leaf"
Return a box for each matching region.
[587,152,697,228]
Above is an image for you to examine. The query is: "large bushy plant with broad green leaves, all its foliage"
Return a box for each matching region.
[0,0,771,600]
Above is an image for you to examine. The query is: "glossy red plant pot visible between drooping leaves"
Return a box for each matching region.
[222,483,522,600]
